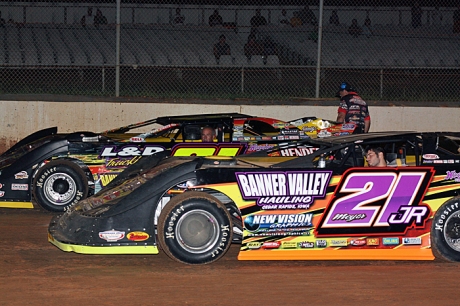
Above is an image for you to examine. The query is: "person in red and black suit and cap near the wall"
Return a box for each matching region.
[337,82,371,134]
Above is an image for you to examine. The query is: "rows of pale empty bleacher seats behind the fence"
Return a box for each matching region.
[0,24,460,68]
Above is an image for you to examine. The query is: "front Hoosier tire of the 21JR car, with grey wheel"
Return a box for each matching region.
[157,191,233,264]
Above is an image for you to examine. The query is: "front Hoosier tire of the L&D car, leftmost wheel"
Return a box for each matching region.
[33,160,88,212]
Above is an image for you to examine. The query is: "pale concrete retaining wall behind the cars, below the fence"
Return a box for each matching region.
[0,101,460,152]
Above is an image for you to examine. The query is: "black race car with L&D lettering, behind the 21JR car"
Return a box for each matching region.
[0,113,352,212]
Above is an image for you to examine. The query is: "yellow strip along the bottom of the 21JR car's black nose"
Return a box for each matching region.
[48,233,158,254]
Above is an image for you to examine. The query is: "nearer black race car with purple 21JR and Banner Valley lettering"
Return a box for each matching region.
[48,132,460,264]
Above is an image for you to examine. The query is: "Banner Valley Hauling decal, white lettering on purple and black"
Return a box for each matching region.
[236,171,332,210]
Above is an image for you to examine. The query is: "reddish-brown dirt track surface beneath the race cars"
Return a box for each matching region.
[0,209,460,305]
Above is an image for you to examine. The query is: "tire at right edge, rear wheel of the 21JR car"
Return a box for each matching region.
[430,197,460,261]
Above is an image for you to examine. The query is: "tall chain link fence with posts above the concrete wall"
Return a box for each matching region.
[0,0,460,102]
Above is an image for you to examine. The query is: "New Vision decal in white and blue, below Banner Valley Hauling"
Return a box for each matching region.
[244,214,313,235]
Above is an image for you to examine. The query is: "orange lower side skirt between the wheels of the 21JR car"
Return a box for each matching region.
[238,249,434,260]
